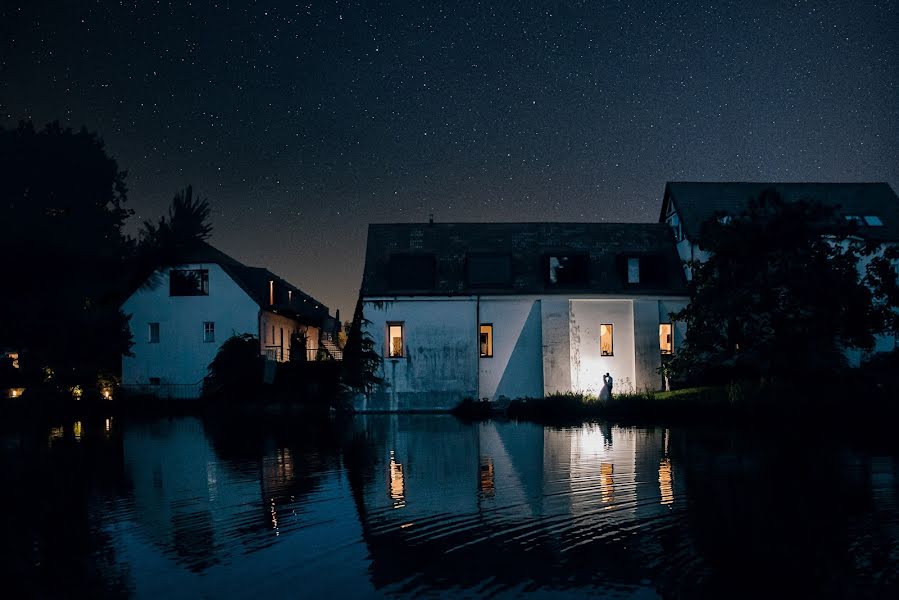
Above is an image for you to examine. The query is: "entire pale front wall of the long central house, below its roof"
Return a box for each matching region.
[366,296,687,411]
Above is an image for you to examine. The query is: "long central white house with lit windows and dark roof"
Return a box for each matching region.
[357,223,688,410]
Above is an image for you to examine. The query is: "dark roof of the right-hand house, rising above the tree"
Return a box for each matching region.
[659,181,899,241]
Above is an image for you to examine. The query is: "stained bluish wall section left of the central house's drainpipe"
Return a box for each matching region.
[357,298,478,411]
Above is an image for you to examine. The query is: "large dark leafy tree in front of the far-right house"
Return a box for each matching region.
[670,191,895,379]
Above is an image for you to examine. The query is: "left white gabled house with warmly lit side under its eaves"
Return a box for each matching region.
[122,243,336,398]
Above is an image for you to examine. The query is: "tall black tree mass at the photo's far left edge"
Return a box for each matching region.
[0,122,131,383]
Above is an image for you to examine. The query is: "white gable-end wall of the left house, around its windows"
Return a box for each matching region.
[122,264,259,385]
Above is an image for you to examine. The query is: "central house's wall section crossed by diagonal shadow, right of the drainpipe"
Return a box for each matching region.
[478,297,543,400]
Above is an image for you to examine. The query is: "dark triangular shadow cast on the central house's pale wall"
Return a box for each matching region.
[495,302,543,399]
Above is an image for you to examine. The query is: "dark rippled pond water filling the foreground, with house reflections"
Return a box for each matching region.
[0,415,899,599]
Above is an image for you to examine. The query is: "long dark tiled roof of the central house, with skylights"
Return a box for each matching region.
[362,223,686,297]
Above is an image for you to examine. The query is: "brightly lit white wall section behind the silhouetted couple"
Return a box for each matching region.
[570,300,636,394]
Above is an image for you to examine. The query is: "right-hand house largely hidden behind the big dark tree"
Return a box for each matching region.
[659,181,899,366]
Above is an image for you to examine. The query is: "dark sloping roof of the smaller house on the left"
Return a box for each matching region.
[149,242,328,321]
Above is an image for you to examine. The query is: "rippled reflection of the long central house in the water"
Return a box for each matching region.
[348,415,688,595]
